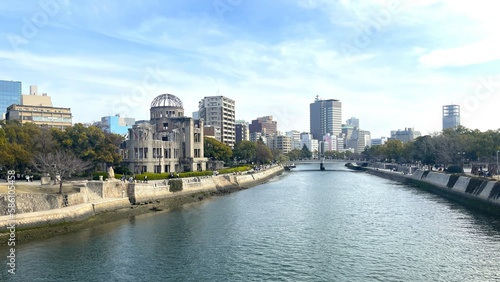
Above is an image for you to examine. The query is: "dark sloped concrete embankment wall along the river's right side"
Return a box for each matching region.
[367,169,500,215]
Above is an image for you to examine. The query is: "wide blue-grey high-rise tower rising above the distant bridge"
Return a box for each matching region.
[309,96,342,140]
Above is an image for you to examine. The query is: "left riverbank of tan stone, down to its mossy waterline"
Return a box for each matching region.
[0,166,283,245]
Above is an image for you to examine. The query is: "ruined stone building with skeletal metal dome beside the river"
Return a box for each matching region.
[122,94,207,174]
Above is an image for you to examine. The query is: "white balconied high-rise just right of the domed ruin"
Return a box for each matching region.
[198,96,236,148]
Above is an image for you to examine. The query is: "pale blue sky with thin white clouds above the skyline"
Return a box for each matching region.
[0,0,500,138]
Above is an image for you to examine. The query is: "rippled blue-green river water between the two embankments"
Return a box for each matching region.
[0,163,500,281]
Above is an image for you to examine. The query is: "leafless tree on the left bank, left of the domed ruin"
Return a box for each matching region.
[33,151,92,194]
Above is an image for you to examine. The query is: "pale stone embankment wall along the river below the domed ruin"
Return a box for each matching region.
[0,166,283,233]
